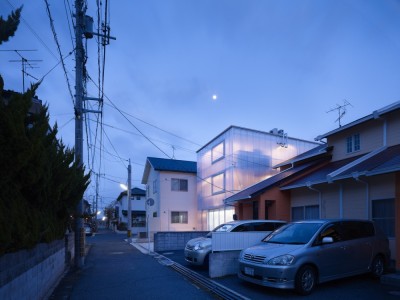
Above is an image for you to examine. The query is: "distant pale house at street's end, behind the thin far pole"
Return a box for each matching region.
[115,187,147,235]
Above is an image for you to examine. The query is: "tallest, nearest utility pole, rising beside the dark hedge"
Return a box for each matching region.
[74,0,85,269]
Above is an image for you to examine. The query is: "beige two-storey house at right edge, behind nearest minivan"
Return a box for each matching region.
[281,102,400,269]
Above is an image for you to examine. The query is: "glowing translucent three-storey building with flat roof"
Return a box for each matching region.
[197,126,320,230]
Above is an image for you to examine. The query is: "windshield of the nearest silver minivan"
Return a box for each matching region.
[262,223,322,245]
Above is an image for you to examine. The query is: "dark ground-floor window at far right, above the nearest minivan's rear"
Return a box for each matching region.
[372,199,395,237]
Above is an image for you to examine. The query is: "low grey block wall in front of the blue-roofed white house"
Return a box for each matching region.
[154,231,208,252]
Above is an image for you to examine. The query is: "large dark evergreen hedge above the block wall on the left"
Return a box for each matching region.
[0,86,89,255]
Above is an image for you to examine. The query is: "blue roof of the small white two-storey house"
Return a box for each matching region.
[142,157,197,184]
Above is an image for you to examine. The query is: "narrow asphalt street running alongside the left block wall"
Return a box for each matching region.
[49,229,215,300]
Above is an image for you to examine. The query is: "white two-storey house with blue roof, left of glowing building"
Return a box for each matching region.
[142,157,199,237]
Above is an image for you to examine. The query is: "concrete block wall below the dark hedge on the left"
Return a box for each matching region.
[0,235,74,300]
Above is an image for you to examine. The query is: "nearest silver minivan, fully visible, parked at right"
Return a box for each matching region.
[238,219,390,295]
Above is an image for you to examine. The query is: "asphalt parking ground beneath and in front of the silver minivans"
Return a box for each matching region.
[160,250,400,300]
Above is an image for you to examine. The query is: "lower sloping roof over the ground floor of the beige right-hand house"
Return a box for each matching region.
[281,145,400,190]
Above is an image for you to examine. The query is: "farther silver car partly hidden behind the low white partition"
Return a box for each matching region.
[185,220,286,266]
